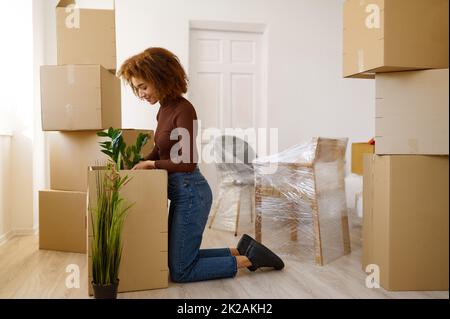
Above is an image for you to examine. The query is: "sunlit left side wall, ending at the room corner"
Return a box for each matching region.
[0,1,34,240]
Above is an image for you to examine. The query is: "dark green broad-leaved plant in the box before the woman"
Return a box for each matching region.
[97,127,149,169]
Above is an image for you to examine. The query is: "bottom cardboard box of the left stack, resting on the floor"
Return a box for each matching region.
[39,190,87,254]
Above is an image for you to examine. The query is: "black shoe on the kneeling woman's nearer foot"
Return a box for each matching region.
[245,240,284,271]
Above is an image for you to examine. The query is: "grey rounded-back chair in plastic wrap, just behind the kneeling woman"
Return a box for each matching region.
[209,135,256,236]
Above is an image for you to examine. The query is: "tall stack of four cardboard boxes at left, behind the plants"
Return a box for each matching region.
[39,1,122,253]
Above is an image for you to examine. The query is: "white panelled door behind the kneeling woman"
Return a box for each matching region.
[189,29,263,191]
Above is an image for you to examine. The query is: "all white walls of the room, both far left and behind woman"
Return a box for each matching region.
[0,0,374,237]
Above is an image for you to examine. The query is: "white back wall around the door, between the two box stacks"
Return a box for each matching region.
[116,0,374,168]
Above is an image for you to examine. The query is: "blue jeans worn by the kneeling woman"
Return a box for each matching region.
[168,168,237,282]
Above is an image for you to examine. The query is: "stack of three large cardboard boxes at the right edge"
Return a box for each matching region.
[344,0,449,290]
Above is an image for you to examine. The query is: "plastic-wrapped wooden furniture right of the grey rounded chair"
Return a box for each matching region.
[254,137,350,265]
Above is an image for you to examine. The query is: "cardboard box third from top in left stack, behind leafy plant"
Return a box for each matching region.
[47,130,154,192]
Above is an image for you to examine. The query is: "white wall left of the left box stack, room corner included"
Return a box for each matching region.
[0,0,57,241]
